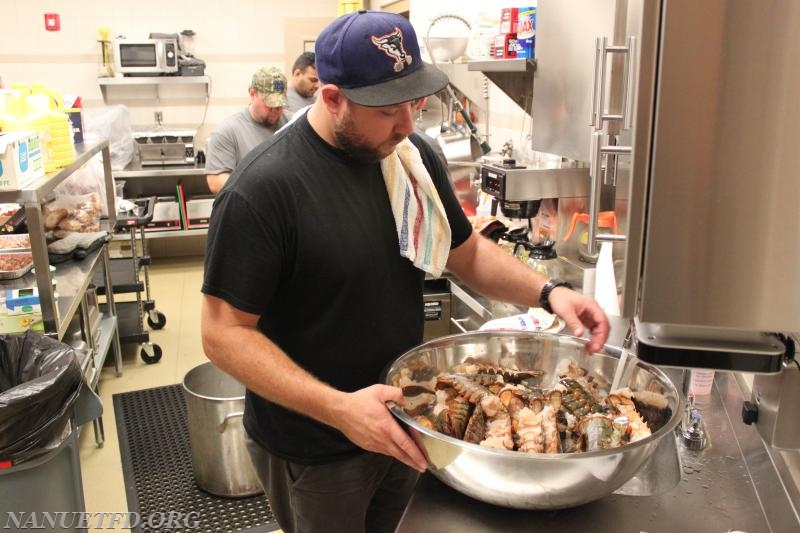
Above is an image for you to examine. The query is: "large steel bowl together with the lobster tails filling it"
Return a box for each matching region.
[385,331,683,509]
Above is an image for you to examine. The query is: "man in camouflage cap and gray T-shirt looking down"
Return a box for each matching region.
[206,67,288,194]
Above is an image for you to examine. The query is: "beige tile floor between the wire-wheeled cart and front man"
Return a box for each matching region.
[80,257,214,531]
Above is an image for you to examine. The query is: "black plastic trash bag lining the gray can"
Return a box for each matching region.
[0,331,83,463]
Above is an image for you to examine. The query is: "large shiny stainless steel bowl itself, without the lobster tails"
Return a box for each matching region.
[385,331,684,509]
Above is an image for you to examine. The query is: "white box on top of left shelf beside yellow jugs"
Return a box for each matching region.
[0,132,44,191]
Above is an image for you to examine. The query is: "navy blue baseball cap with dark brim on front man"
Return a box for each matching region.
[315,10,448,106]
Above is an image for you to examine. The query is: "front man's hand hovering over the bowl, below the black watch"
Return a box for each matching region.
[548,287,608,353]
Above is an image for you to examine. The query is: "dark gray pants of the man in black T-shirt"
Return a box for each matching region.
[245,432,418,533]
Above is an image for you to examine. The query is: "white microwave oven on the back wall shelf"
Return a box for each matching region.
[113,38,178,76]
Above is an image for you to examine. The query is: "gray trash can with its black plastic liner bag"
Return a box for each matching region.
[0,331,102,531]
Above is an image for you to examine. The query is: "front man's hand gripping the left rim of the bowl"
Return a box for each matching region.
[335,385,428,472]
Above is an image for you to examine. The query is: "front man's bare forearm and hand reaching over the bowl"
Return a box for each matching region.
[447,231,608,352]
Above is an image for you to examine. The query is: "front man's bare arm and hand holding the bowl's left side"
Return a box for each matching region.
[200,295,427,471]
